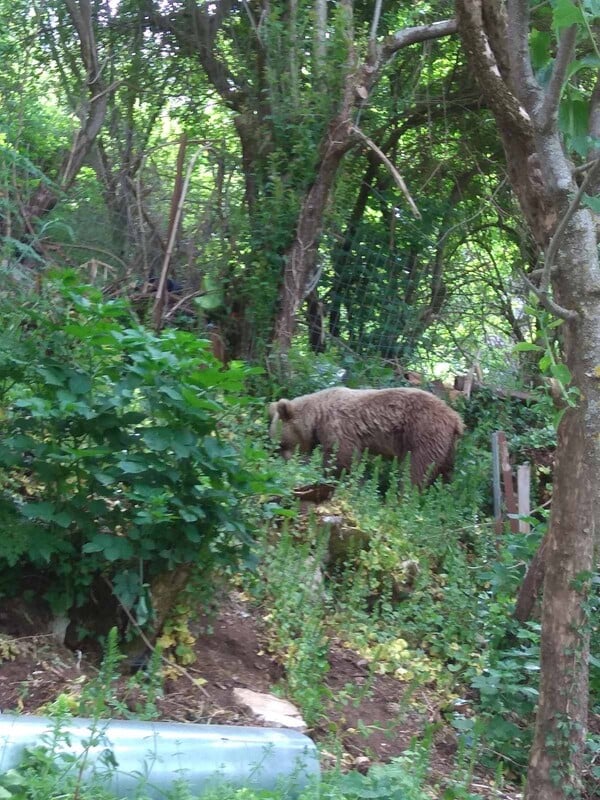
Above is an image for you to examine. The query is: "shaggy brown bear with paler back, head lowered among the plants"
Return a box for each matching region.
[269,386,464,487]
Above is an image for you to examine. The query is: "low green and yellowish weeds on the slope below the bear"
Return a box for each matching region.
[249,442,543,774]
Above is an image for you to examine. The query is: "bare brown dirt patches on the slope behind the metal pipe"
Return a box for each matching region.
[0,593,521,800]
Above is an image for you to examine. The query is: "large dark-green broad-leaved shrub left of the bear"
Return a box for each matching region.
[0,273,262,636]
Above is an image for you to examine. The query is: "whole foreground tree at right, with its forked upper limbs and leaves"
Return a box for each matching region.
[456,0,600,800]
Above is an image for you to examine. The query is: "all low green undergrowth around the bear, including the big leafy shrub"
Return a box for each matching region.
[0,274,600,800]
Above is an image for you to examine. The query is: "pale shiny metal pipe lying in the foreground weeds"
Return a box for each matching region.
[0,714,320,798]
